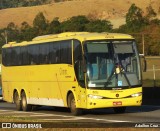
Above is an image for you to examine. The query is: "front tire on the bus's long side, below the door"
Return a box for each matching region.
[68,93,82,116]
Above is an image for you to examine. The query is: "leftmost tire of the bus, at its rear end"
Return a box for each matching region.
[13,91,22,111]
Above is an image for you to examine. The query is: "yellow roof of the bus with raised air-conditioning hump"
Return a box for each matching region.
[3,32,133,48]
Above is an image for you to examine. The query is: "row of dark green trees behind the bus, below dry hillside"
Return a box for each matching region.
[0,3,160,55]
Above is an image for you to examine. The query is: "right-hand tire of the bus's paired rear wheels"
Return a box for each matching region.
[21,92,32,111]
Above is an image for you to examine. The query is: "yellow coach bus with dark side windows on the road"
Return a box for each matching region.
[2,32,142,115]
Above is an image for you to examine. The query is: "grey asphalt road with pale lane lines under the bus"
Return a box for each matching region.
[0,101,160,128]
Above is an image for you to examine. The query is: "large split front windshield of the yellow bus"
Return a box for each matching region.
[84,40,142,89]
